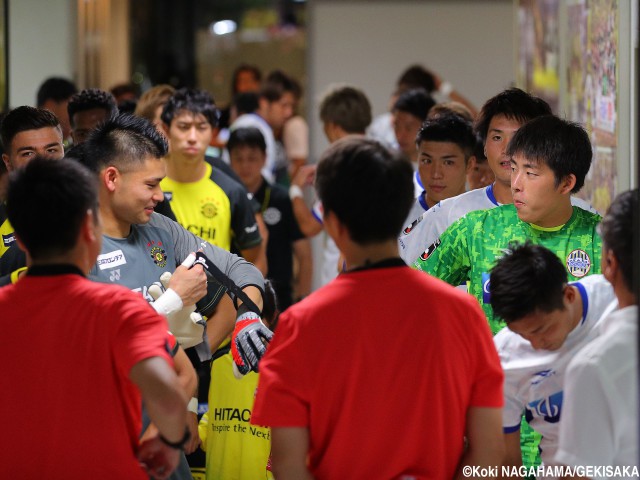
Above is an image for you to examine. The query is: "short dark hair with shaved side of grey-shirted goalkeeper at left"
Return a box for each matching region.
[83,113,168,172]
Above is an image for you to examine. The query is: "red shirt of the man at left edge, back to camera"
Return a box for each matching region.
[0,274,173,480]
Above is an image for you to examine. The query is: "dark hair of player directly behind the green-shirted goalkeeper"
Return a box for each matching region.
[475,88,551,143]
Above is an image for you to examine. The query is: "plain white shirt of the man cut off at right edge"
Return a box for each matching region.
[556,305,638,478]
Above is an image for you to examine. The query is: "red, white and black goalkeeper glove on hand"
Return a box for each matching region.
[231,304,273,378]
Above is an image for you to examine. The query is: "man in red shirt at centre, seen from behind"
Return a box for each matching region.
[251,138,504,480]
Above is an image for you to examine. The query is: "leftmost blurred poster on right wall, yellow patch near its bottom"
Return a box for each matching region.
[517,0,560,113]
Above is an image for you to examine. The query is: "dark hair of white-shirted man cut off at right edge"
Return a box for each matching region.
[599,188,638,293]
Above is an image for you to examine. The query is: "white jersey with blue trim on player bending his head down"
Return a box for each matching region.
[494,275,617,472]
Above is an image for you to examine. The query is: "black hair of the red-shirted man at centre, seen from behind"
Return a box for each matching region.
[316,137,414,245]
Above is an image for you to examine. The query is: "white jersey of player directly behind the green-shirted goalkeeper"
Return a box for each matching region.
[398,184,598,265]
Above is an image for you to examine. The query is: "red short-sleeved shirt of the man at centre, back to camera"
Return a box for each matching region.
[251,266,503,479]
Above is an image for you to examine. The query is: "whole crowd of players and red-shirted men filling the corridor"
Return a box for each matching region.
[0,64,639,480]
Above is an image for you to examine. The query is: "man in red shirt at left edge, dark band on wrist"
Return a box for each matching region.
[0,159,189,479]
